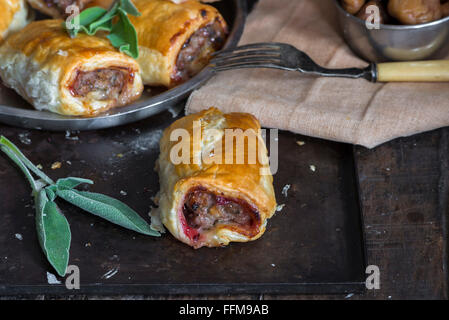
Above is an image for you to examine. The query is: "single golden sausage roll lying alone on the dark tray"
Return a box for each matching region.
[151,108,276,248]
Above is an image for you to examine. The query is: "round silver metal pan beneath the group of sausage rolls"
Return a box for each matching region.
[0,0,247,131]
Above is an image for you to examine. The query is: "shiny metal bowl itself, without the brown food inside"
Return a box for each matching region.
[334,0,449,62]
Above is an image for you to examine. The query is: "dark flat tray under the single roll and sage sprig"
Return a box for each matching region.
[0,112,365,295]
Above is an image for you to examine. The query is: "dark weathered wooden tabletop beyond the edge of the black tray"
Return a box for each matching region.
[0,121,449,299]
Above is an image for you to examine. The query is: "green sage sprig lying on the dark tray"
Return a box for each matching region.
[0,136,160,276]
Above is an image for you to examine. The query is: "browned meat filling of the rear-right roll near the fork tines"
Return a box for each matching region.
[172,21,226,84]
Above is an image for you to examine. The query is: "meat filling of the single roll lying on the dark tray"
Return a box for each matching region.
[183,188,260,237]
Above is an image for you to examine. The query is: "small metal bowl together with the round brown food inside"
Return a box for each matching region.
[334,0,449,62]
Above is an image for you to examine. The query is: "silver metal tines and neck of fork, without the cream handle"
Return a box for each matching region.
[210,42,377,82]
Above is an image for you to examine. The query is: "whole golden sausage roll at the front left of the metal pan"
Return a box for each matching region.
[0,20,143,116]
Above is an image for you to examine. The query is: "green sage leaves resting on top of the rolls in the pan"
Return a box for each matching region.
[63,0,140,59]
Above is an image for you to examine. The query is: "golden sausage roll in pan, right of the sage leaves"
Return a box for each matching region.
[130,0,227,87]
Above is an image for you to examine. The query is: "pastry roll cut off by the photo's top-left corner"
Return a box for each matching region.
[0,0,30,43]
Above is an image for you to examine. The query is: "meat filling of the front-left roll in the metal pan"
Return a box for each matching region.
[71,68,129,100]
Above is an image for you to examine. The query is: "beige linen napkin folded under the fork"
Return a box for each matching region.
[186,0,449,148]
